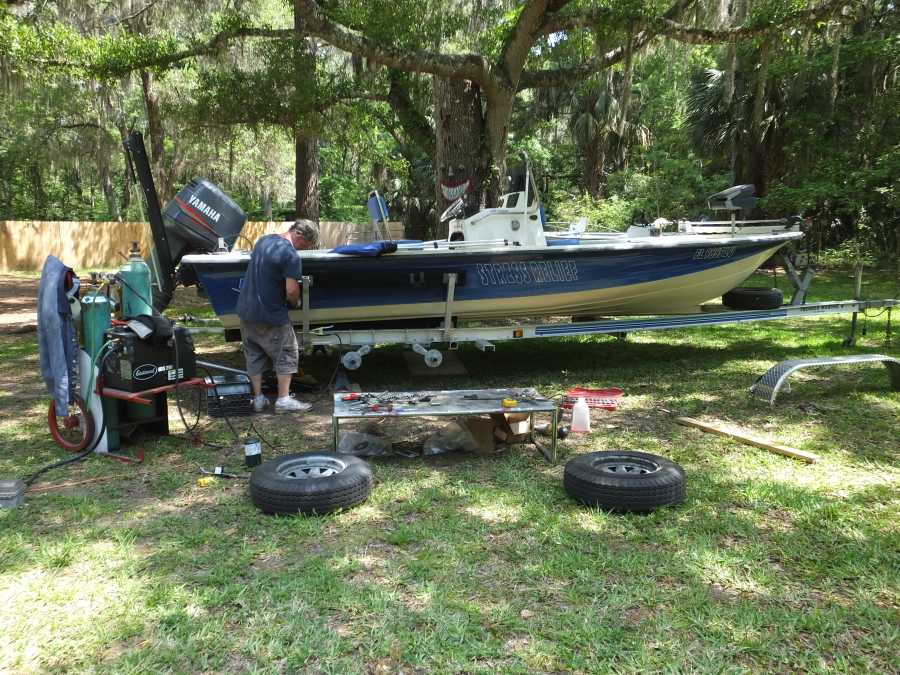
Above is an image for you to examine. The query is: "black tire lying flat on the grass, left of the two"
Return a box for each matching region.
[250,452,375,515]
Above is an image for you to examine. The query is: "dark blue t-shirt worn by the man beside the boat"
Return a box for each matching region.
[237,234,300,326]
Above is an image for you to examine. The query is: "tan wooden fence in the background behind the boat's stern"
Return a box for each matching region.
[0,220,403,272]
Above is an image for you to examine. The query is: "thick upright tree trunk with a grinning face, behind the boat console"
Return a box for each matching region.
[433,77,488,236]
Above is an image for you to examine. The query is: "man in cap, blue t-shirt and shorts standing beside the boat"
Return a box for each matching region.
[237,220,319,412]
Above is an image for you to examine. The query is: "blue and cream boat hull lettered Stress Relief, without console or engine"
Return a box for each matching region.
[182,232,802,328]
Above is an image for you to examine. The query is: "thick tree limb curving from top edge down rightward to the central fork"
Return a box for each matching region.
[294,0,489,84]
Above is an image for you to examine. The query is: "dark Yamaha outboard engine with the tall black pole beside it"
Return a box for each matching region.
[125,132,247,311]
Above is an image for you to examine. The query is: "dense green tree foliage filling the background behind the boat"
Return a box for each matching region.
[0,0,900,260]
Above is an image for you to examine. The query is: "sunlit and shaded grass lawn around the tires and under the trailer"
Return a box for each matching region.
[0,273,900,673]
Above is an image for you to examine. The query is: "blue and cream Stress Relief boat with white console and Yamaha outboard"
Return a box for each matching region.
[125,133,803,329]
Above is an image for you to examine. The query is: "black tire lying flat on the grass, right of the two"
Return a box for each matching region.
[563,450,685,512]
